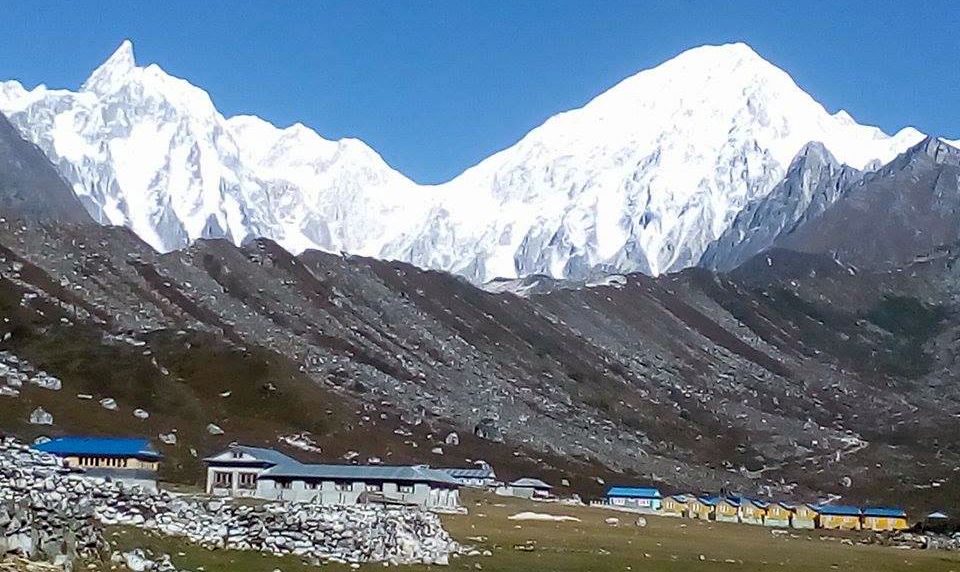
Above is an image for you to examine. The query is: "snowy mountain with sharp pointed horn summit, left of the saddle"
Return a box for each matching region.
[0,42,428,254]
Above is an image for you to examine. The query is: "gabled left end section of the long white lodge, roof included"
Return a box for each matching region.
[203,445,300,497]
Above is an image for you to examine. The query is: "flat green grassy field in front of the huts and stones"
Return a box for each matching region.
[101,492,960,572]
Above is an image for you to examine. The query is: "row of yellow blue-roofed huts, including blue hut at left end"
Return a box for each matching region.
[604,486,909,531]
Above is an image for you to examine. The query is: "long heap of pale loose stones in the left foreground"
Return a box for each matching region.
[0,439,458,565]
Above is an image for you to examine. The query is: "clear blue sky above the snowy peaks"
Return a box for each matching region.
[0,0,960,182]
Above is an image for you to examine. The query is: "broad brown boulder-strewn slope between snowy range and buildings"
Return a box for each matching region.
[0,171,960,506]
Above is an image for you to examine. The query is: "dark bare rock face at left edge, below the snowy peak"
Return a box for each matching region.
[0,114,92,223]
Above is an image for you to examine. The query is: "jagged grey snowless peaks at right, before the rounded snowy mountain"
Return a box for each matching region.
[700,137,960,270]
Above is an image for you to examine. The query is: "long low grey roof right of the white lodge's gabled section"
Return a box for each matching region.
[260,463,460,485]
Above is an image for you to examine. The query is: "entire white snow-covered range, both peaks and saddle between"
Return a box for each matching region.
[0,42,923,282]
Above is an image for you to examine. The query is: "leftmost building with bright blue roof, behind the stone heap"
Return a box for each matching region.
[33,437,163,490]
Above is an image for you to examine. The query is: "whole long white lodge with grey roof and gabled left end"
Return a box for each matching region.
[204,445,460,510]
